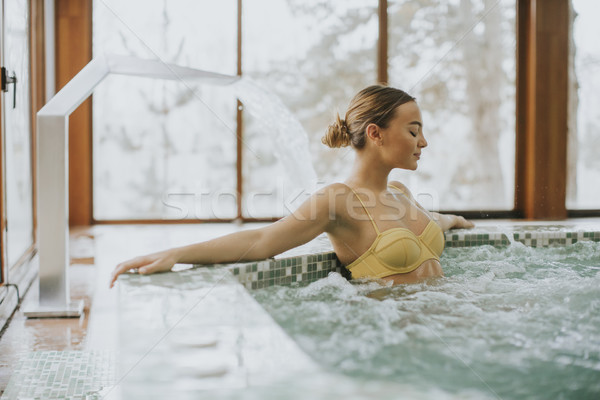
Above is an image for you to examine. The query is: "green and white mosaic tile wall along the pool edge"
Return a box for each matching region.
[224,226,600,289]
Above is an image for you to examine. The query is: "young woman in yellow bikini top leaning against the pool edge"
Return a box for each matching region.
[110,85,473,287]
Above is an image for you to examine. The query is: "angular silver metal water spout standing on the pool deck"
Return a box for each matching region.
[24,55,239,318]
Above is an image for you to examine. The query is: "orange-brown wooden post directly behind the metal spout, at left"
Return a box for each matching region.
[55,0,92,226]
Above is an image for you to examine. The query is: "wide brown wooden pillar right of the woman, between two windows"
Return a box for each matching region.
[515,0,569,219]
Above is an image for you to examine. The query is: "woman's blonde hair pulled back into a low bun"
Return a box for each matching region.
[321,85,415,149]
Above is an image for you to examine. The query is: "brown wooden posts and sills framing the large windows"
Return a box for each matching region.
[56,0,600,226]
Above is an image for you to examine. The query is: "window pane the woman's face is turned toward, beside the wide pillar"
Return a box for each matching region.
[388,0,516,210]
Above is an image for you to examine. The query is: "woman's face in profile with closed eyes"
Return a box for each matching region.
[381,101,427,170]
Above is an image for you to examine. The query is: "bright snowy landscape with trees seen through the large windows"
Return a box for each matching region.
[94,0,600,220]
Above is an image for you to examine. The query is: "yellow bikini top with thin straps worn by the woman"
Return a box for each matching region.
[346,185,445,279]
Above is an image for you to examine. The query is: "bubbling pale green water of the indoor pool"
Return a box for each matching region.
[252,242,600,399]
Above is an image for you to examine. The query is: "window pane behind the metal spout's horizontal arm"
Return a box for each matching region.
[93,0,237,220]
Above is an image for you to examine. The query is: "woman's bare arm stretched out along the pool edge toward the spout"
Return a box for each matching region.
[110,184,339,287]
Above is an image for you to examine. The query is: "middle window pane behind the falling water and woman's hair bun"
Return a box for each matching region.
[242,0,379,217]
